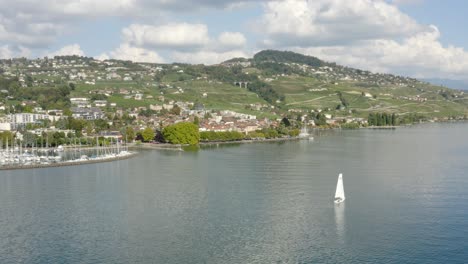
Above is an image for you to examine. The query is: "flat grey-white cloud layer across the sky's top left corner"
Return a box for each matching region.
[0,0,260,49]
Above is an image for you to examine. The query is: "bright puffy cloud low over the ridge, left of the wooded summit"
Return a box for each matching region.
[108,23,247,64]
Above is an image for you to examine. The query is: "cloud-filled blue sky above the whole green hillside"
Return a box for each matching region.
[0,0,468,80]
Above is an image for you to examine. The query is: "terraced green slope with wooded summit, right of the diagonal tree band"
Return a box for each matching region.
[224,50,467,117]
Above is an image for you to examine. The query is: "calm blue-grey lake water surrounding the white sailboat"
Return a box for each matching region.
[0,123,468,263]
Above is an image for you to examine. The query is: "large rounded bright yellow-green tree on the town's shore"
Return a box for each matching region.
[163,122,200,145]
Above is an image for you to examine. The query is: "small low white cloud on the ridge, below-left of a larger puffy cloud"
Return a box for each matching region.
[102,43,164,63]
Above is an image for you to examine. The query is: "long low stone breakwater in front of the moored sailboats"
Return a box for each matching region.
[0,152,138,170]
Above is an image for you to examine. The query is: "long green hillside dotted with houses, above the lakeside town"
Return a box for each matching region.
[0,50,468,123]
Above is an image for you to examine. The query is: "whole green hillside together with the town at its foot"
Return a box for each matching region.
[0,51,467,144]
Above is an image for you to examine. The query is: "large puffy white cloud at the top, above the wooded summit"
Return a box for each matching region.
[258,0,428,47]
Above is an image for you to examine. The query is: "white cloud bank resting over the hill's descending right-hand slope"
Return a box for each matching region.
[292,27,468,80]
